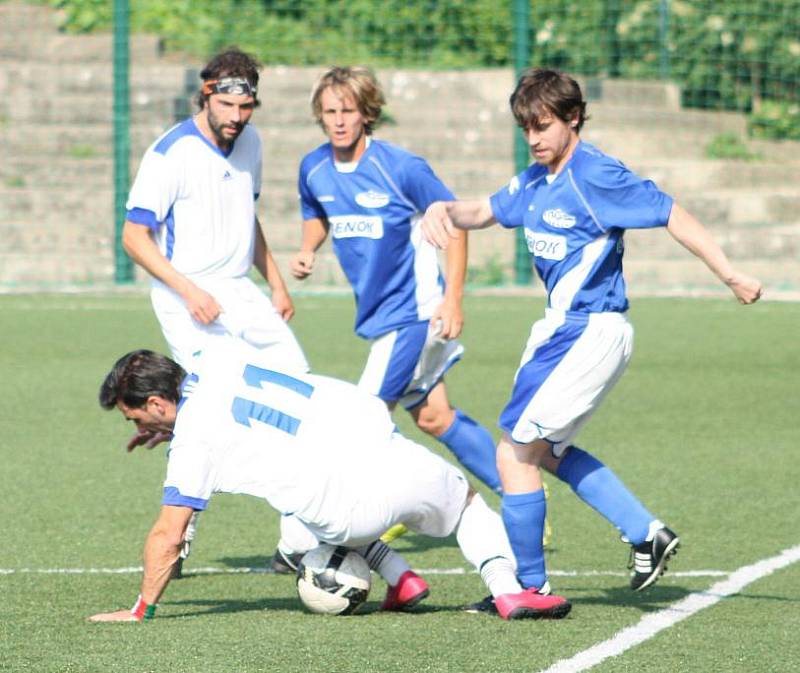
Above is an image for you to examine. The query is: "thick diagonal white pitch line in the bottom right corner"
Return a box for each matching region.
[541,545,800,673]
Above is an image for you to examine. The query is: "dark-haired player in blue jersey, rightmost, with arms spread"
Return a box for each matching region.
[423,69,762,615]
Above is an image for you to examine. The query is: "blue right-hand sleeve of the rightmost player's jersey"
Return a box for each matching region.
[577,157,672,231]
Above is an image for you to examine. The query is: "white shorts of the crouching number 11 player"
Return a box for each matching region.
[295,433,469,547]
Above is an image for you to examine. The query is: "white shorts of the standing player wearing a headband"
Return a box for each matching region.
[150,277,308,372]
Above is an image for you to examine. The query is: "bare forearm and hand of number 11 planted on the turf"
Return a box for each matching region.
[89,505,194,622]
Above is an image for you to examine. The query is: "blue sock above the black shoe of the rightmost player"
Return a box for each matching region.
[556,446,655,544]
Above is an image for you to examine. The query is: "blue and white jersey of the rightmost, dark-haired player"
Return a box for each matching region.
[491,141,672,313]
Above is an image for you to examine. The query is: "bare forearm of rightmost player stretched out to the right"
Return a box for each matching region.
[667,203,763,304]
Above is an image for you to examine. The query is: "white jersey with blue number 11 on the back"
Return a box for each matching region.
[162,339,394,523]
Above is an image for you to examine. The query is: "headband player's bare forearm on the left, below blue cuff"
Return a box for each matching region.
[122,220,222,325]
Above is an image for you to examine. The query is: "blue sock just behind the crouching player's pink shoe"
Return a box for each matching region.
[501,489,547,589]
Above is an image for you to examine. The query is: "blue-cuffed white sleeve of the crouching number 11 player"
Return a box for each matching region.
[161,437,214,510]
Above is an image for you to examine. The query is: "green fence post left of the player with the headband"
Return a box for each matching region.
[113,0,133,285]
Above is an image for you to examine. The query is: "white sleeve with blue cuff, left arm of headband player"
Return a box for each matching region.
[125,150,180,229]
